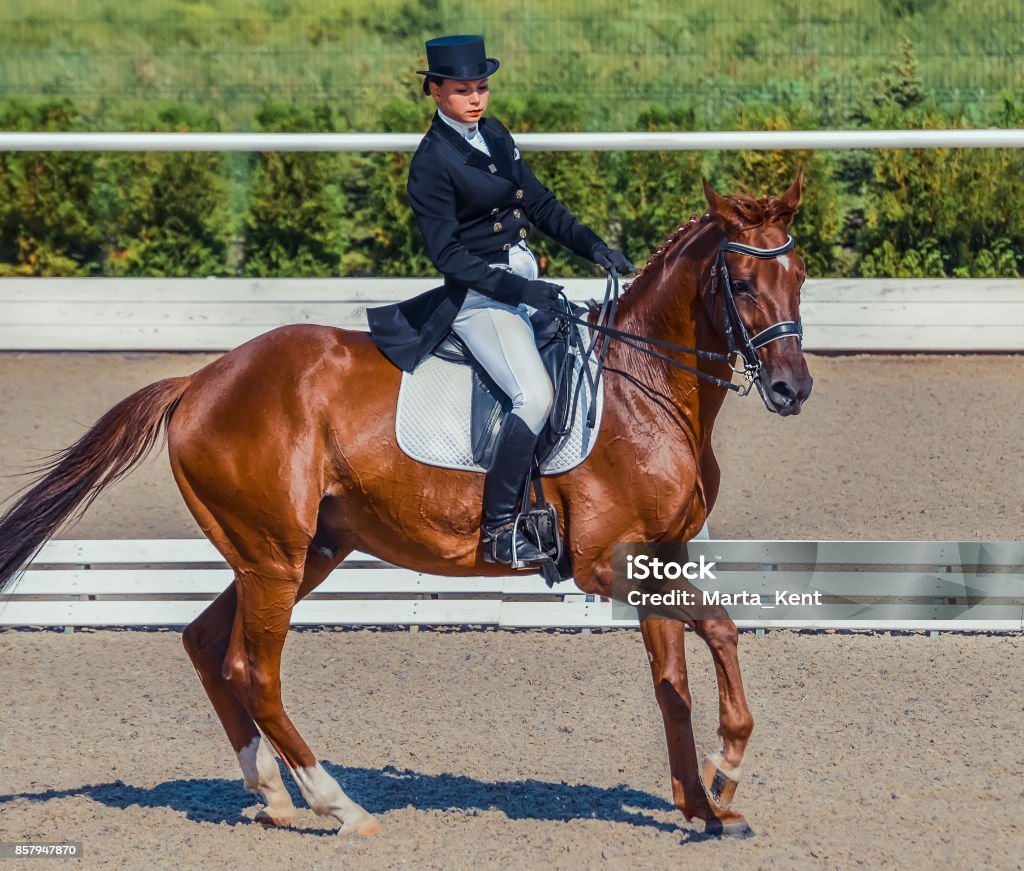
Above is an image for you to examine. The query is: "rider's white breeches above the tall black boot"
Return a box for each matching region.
[452,243,554,435]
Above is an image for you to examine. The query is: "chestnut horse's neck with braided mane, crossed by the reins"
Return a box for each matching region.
[615,222,729,444]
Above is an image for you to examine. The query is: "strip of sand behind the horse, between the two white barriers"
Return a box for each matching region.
[0,354,1024,539]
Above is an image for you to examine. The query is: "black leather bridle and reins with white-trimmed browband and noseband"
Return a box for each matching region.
[552,230,804,428]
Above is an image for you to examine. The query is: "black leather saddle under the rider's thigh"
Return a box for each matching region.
[433,301,586,469]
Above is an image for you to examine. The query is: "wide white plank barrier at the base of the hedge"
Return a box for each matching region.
[0,278,1024,353]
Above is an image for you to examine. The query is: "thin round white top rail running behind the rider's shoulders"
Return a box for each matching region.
[0,128,1024,151]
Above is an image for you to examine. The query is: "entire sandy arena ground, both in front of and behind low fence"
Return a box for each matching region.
[0,354,1024,871]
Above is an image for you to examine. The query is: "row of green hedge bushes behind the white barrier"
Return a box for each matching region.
[0,72,1024,277]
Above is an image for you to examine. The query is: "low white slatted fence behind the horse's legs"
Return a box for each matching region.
[0,539,1024,632]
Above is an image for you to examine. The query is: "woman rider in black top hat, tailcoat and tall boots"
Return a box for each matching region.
[369,36,633,567]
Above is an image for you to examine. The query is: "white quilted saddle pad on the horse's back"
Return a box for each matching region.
[395,326,604,475]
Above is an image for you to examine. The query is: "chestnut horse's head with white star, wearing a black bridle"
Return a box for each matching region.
[703,170,812,416]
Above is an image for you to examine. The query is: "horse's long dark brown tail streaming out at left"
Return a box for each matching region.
[0,376,191,595]
